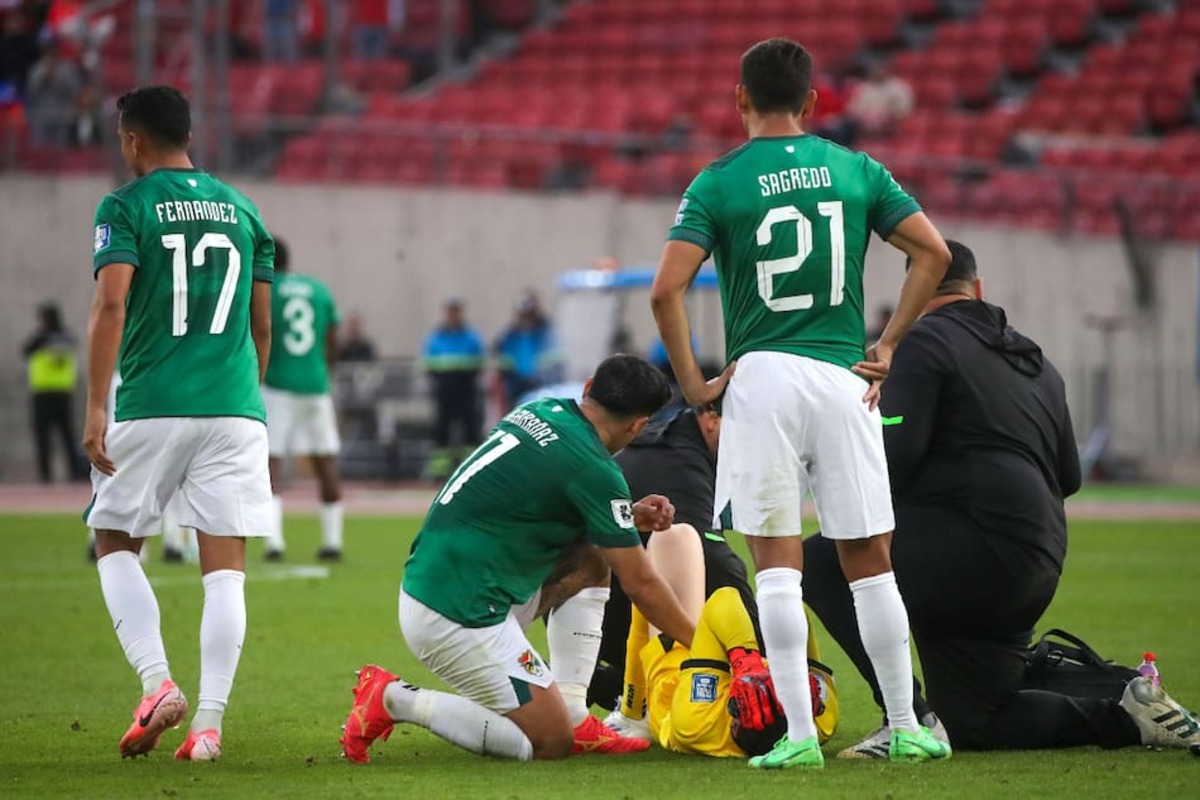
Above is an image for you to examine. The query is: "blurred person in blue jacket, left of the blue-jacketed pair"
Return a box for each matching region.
[421,297,484,481]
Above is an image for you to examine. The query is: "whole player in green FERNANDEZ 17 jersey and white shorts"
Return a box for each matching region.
[83,86,275,760]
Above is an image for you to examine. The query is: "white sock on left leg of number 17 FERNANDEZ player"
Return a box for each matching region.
[96,551,170,694]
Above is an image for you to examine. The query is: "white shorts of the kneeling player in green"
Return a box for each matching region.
[400,589,554,714]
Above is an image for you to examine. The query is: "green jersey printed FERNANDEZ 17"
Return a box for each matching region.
[92,169,275,422]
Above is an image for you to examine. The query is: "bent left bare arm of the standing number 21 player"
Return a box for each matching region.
[650,241,734,405]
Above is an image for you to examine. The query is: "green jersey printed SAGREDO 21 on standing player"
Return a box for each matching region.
[668,134,920,367]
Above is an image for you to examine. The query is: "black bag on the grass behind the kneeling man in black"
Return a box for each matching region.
[1021,627,1138,699]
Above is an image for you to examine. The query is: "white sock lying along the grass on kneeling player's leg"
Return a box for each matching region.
[383,680,533,762]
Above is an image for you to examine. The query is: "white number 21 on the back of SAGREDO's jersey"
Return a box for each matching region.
[755,200,846,311]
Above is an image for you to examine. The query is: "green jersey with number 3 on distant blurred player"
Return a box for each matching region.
[263,272,341,395]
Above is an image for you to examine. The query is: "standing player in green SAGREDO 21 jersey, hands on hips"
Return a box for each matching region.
[652,38,950,769]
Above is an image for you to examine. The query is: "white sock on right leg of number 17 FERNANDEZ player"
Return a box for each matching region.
[192,570,246,733]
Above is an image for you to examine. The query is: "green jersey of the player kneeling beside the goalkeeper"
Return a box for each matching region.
[403,399,642,627]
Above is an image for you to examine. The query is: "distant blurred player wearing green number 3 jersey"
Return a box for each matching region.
[263,239,342,561]
